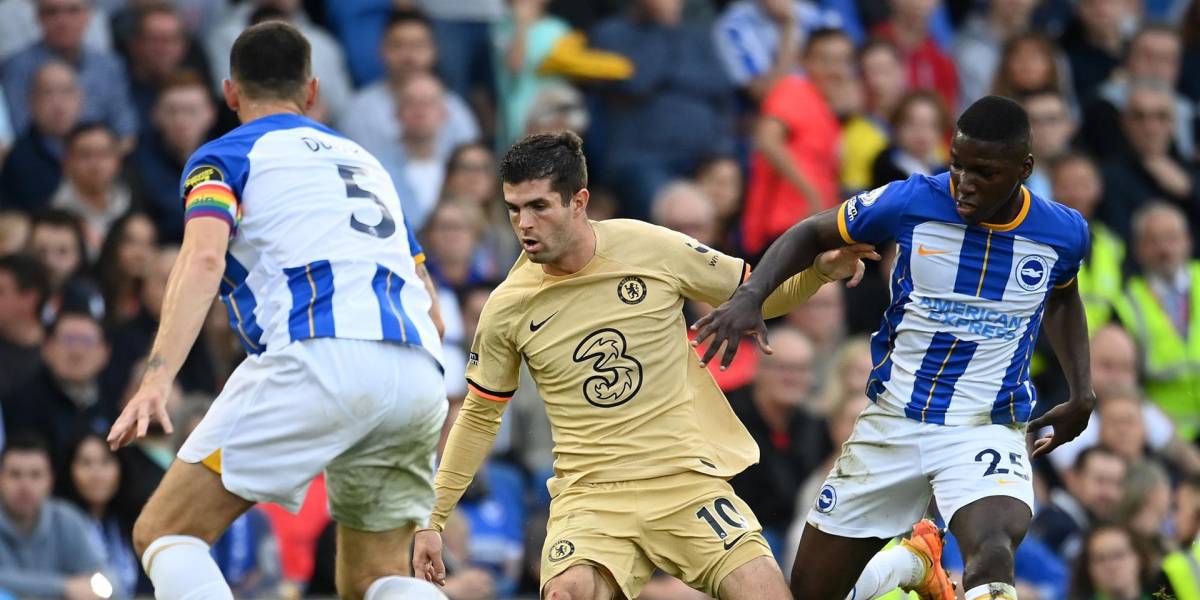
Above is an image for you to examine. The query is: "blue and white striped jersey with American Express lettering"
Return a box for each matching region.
[838,173,1088,425]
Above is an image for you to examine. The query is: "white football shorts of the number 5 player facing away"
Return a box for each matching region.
[179,337,448,532]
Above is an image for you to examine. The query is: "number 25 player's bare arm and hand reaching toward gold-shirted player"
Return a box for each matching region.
[692,208,846,368]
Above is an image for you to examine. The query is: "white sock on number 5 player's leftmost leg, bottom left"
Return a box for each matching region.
[142,535,233,600]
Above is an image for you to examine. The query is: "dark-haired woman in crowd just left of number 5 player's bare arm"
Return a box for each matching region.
[96,211,158,325]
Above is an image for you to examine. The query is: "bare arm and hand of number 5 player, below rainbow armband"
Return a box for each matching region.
[108,217,230,450]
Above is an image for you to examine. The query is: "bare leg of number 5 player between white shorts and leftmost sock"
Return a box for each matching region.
[133,461,254,557]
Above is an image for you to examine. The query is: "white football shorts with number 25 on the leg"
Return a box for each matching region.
[808,393,1033,539]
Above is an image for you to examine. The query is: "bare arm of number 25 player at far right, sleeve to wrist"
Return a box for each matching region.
[1043,282,1096,409]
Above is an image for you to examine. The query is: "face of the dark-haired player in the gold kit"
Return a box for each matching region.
[504,179,583,264]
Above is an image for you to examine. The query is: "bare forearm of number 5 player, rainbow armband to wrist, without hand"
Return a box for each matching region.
[143,218,229,385]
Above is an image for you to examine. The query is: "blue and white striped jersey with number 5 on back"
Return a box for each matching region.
[180,114,442,361]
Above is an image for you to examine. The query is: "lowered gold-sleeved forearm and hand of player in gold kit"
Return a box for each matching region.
[413,391,508,586]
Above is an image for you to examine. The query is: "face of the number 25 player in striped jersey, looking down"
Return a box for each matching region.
[950,132,1033,224]
